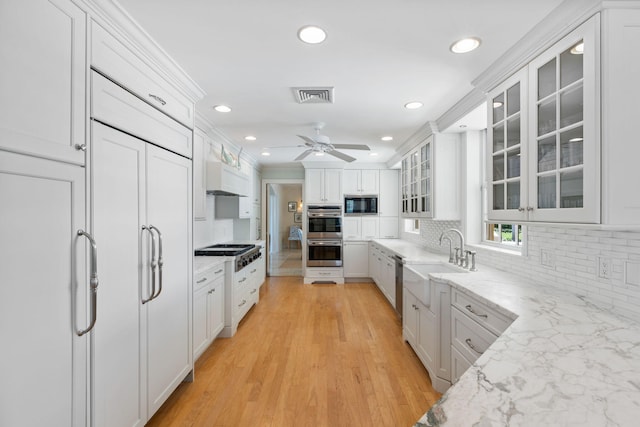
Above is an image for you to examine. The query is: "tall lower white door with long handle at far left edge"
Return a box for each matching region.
[0,150,87,427]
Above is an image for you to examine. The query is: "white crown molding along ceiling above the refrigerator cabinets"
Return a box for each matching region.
[79,0,206,103]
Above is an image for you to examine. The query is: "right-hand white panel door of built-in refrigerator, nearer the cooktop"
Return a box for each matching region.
[146,144,193,415]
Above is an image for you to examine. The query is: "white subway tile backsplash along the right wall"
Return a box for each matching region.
[403,220,640,321]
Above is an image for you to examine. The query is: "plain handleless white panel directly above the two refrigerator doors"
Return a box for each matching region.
[91,71,193,158]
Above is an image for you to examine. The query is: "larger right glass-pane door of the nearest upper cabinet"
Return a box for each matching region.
[527,18,600,222]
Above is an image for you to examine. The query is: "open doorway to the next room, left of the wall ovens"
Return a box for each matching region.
[265,180,305,276]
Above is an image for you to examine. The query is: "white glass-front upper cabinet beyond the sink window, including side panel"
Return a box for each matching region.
[401,133,460,220]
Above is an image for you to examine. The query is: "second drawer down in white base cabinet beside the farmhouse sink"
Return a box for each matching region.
[451,307,498,362]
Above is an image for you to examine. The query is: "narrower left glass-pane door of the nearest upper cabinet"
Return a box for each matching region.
[487,69,528,220]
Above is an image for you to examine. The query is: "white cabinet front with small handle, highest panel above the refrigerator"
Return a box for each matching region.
[91,22,194,129]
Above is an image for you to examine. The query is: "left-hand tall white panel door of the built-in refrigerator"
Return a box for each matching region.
[91,122,149,427]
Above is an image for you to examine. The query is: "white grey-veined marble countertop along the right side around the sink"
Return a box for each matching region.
[376,240,640,427]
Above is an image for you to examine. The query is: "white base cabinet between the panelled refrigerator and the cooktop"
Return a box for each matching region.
[193,261,224,360]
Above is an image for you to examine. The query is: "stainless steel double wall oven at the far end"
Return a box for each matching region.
[307,205,342,267]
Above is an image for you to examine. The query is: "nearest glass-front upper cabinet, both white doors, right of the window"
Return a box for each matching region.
[487,16,600,223]
